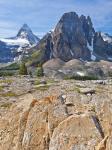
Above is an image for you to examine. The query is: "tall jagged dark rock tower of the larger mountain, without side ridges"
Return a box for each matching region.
[53,12,94,61]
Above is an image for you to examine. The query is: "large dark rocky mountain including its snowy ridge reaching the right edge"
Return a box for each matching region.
[33,12,112,61]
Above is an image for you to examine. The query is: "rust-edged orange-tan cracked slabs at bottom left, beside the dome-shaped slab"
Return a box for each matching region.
[0,97,68,150]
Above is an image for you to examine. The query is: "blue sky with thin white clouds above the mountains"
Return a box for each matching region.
[0,0,112,38]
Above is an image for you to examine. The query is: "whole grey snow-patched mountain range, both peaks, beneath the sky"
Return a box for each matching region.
[0,12,112,62]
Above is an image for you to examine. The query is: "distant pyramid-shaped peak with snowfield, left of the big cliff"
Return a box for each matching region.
[0,24,39,63]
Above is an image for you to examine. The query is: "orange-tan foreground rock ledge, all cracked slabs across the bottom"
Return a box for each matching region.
[0,95,112,150]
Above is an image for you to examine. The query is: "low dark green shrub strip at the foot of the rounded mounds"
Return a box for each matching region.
[64,76,98,81]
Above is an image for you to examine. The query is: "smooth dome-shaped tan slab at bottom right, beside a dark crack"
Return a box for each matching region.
[50,114,101,150]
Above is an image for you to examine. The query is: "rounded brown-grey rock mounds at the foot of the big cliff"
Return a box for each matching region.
[43,58,112,79]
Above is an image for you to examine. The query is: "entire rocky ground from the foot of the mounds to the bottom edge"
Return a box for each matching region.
[0,76,112,150]
